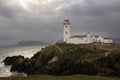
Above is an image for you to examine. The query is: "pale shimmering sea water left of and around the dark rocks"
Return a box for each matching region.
[0,45,46,77]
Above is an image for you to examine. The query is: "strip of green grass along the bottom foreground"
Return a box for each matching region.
[0,75,120,80]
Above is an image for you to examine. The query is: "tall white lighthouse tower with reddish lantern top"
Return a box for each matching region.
[63,19,70,42]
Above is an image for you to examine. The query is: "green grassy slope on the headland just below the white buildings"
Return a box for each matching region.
[44,43,107,62]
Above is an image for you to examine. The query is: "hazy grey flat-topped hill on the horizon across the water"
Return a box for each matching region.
[17,41,47,46]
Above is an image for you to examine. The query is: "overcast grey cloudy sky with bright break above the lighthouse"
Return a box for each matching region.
[0,0,120,45]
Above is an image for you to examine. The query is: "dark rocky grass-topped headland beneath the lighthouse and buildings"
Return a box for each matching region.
[3,43,120,77]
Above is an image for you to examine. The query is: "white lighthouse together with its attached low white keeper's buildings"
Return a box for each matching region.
[63,19,113,44]
